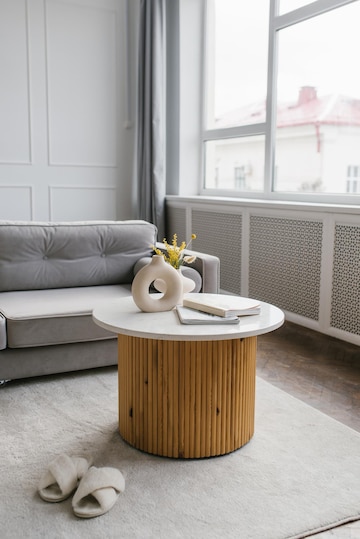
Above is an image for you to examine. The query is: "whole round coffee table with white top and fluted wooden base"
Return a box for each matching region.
[93,296,284,458]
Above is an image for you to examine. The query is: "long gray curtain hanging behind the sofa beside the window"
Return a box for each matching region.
[137,0,166,241]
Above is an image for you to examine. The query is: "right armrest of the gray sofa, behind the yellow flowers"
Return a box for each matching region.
[156,242,220,294]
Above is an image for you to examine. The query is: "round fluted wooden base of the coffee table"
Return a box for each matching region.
[118,335,256,458]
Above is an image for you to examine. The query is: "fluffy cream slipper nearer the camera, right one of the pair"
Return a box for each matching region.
[72,466,125,518]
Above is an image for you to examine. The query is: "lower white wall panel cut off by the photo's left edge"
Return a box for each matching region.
[0,185,33,221]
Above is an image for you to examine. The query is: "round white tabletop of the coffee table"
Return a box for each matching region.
[92,296,284,341]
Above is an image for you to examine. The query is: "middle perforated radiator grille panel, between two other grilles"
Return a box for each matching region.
[249,216,323,320]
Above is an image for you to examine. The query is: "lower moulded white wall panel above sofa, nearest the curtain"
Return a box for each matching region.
[49,187,116,221]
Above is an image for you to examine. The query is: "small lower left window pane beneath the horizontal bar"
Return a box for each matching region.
[205,135,265,192]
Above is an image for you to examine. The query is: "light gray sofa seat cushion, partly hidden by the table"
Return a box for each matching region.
[0,285,131,348]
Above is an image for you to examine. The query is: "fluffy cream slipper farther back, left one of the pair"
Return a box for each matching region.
[38,455,91,502]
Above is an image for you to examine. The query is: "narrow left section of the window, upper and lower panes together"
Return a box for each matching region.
[204,0,269,193]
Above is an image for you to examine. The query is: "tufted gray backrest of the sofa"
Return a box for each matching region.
[0,221,157,292]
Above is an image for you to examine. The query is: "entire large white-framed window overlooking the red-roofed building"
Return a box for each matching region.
[202,0,360,203]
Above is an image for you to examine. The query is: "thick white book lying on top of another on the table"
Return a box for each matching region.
[183,293,260,318]
